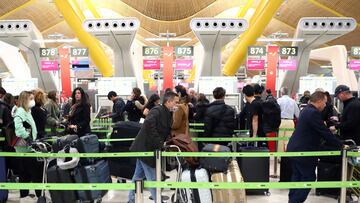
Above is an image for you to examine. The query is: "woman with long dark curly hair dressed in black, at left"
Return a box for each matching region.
[68,87,91,137]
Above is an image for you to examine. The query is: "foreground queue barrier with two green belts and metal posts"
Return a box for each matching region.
[0,150,360,203]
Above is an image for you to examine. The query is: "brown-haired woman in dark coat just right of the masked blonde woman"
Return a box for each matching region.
[31,89,59,139]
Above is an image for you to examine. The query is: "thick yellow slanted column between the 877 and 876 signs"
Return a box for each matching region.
[54,0,114,77]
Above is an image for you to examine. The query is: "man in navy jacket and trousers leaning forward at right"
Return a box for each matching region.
[287,91,343,203]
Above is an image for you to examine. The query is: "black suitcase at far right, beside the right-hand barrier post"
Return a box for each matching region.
[315,162,341,198]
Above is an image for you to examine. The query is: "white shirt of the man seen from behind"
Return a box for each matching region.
[277,95,300,119]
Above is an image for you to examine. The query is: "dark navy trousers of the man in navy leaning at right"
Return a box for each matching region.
[289,159,316,203]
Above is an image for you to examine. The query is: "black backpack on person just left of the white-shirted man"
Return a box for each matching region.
[262,97,281,133]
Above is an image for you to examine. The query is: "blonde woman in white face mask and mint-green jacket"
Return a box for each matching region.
[14,91,43,201]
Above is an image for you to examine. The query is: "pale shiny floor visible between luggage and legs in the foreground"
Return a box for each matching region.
[4,159,356,203]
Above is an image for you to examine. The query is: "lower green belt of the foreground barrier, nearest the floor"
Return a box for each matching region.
[0,181,360,190]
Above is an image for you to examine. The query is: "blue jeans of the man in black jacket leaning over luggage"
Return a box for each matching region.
[129,159,156,203]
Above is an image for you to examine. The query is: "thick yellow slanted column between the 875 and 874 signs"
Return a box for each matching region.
[223,0,283,76]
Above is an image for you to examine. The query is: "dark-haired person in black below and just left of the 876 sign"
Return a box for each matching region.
[125,87,146,122]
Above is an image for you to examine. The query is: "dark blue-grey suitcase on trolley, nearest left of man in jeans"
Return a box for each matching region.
[74,160,112,201]
